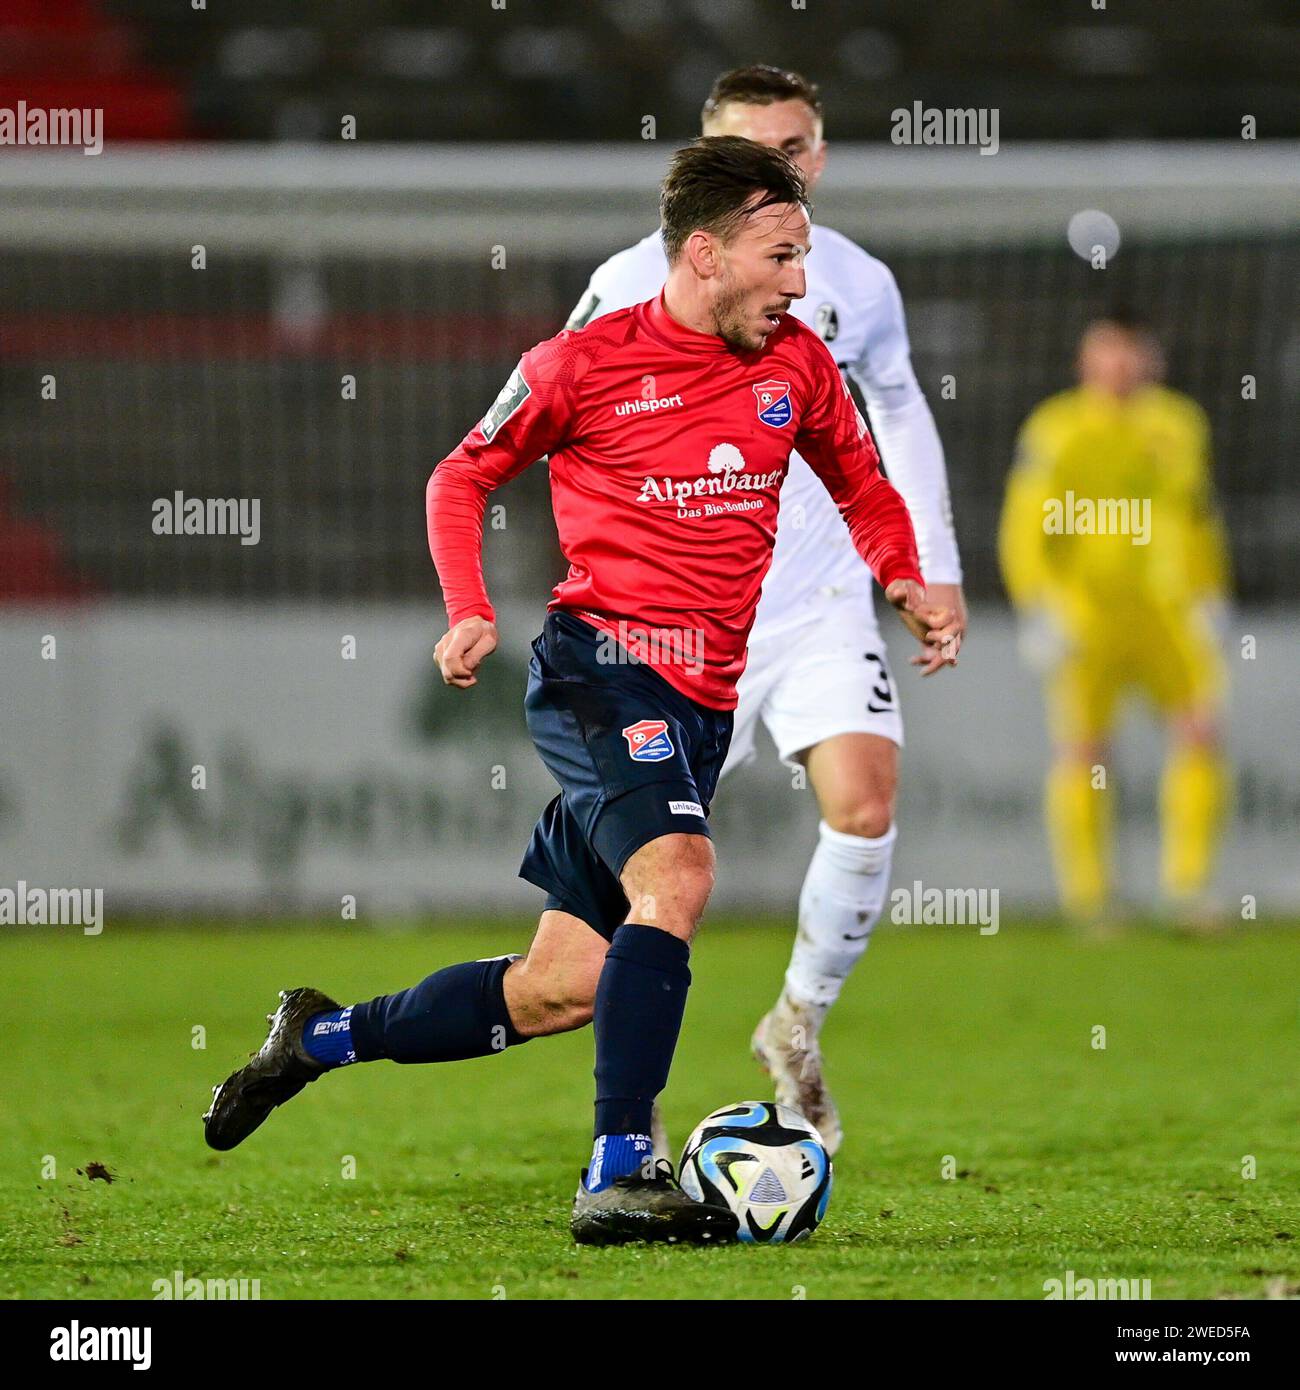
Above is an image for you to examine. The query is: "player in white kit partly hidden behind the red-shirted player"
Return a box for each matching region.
[567,65,965,1152]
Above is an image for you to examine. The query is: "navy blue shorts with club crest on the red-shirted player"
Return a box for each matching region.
[519,612,731,937]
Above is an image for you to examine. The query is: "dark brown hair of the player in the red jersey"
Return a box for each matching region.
[659,135,812,264]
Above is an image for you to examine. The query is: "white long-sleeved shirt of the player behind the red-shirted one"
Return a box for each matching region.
[567,227,961,642]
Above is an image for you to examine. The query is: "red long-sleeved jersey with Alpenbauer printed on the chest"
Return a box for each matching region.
[427,292,920,709]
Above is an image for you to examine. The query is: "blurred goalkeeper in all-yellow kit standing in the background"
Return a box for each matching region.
[998,313,1229,919]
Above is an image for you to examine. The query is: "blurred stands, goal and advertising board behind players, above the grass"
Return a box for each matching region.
[0,0,1300,920]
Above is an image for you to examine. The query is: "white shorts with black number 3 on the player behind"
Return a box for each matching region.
[722,592,902,777]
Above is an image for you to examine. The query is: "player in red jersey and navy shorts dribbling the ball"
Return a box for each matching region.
[204,136,955,1244]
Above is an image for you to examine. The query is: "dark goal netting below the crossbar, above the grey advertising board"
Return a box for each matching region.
[0,234,1300,600]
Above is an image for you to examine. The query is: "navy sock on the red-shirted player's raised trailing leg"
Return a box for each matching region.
[352,956,526,1062]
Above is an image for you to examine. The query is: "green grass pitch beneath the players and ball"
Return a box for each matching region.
[0,923,1300,1298]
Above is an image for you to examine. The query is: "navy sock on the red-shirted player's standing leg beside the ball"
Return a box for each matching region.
[592,922,691,1138]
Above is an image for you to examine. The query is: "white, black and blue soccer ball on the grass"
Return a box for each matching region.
[681,1101,831,1245]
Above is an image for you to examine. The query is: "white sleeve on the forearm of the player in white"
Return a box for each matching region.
[872,396,962,584]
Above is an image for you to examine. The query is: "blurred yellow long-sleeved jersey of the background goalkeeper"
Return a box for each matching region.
[998,386,1229,620]
